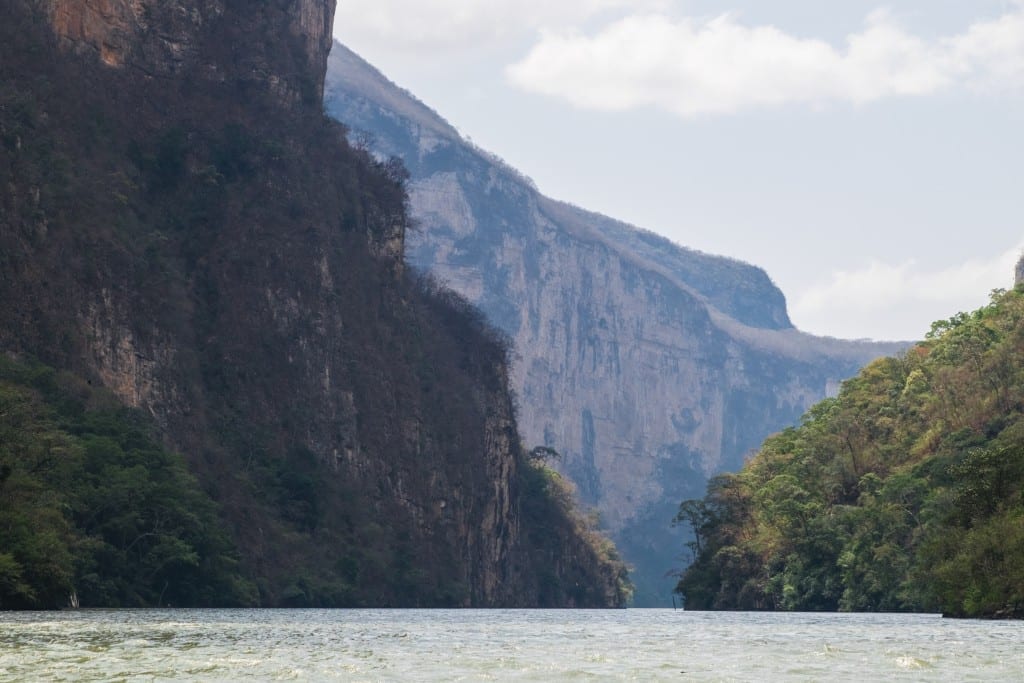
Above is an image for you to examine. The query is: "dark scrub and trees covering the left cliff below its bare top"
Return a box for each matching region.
[0,0,622,607]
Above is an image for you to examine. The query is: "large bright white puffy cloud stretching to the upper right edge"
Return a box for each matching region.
[506,6,1024,117]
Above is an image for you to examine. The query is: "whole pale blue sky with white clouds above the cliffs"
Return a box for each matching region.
[335,0,1024,340]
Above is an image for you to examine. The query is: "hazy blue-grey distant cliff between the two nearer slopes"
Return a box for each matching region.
[327,45,901,605]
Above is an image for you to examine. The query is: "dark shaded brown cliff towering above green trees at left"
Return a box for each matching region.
[0,0,623,606]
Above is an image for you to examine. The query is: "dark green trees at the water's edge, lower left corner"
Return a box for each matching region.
[0,356,254,608]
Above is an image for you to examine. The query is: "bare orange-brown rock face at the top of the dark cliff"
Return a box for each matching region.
[43,0,336,101]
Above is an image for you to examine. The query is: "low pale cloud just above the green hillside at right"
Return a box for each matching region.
[791,242,1024,340]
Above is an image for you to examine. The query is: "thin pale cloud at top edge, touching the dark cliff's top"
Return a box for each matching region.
[335,0,667,53]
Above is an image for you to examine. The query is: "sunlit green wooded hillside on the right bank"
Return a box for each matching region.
[677,289,1024,616]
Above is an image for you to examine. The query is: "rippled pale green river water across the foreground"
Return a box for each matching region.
[0,609,1024,682]
